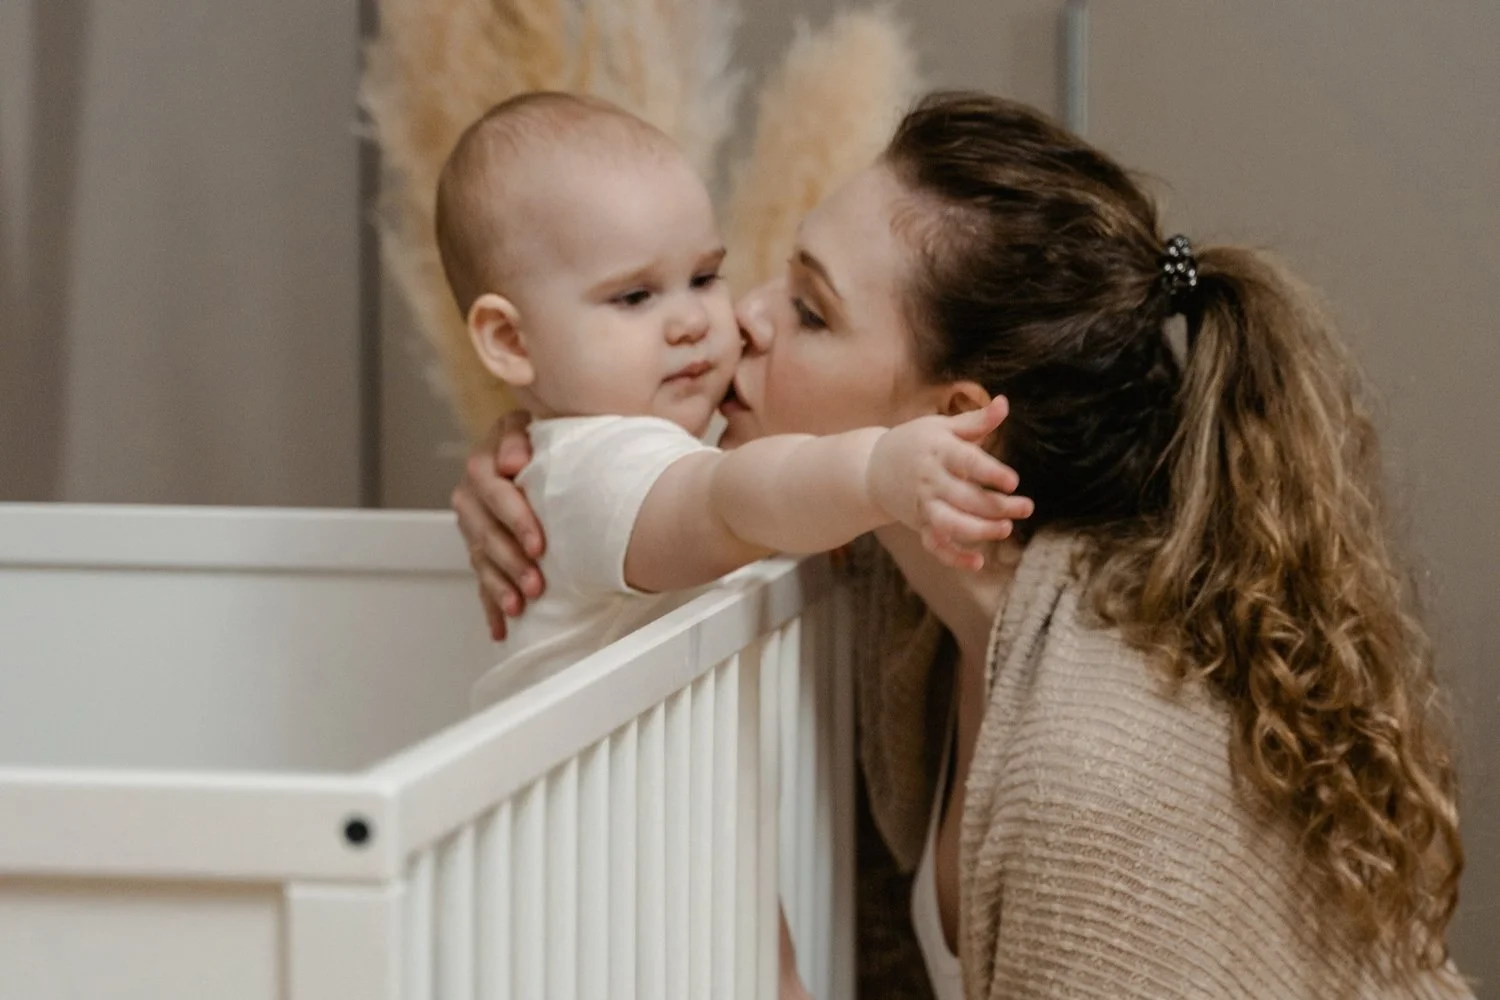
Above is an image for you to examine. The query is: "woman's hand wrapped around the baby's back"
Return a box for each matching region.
[452,411,546,642]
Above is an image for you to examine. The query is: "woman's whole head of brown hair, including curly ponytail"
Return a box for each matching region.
[884,93,1463,970]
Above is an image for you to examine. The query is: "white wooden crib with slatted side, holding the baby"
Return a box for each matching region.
[0,505,854,1000]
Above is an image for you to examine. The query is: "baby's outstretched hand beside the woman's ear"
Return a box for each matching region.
[869,396,1032,570]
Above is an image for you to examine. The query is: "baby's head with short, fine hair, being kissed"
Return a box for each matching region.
[437,93,740,435]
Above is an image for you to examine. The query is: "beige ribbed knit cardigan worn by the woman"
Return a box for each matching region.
[857,532,1472,1000]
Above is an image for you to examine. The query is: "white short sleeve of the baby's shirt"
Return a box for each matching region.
[524,417,713,595]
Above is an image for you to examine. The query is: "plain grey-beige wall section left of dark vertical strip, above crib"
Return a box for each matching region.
[0,0,359,504]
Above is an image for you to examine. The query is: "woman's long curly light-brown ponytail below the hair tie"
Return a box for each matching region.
[1097,247,1463,970]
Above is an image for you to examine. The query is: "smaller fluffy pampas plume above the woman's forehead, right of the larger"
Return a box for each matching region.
[726,7,921,291]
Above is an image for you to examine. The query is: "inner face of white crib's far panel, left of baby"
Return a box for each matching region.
[0,504,494,772]
